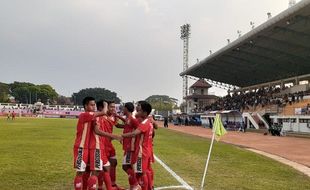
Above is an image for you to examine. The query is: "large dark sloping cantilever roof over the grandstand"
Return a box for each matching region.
[180,0,310,87]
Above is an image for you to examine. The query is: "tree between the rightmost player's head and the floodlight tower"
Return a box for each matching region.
[145,95,178,111]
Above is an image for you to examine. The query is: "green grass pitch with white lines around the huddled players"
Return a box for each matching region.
[0,118,310,190]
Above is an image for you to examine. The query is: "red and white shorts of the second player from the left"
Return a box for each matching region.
[89,149,110,171]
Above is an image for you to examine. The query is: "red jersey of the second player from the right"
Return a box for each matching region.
[123,115,139,151]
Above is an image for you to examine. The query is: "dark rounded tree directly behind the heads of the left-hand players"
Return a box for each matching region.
[72,88,121,105]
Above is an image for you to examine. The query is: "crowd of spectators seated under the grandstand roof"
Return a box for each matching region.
[206,88,308,111]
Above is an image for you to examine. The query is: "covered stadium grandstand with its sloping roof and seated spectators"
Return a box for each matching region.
[180,0,310,133]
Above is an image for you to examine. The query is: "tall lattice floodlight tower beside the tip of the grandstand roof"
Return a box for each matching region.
[181,24,191,112]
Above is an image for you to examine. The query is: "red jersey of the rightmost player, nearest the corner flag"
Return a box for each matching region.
[135,119,153,157]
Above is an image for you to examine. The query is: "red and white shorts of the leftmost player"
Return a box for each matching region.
[73,147,89,172]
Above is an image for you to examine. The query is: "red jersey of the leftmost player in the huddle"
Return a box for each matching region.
[74,112,96,149]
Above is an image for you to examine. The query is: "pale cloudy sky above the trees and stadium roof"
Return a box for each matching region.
[0,0,298,101]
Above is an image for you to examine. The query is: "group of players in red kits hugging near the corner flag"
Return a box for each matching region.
[73,97,157,190]
